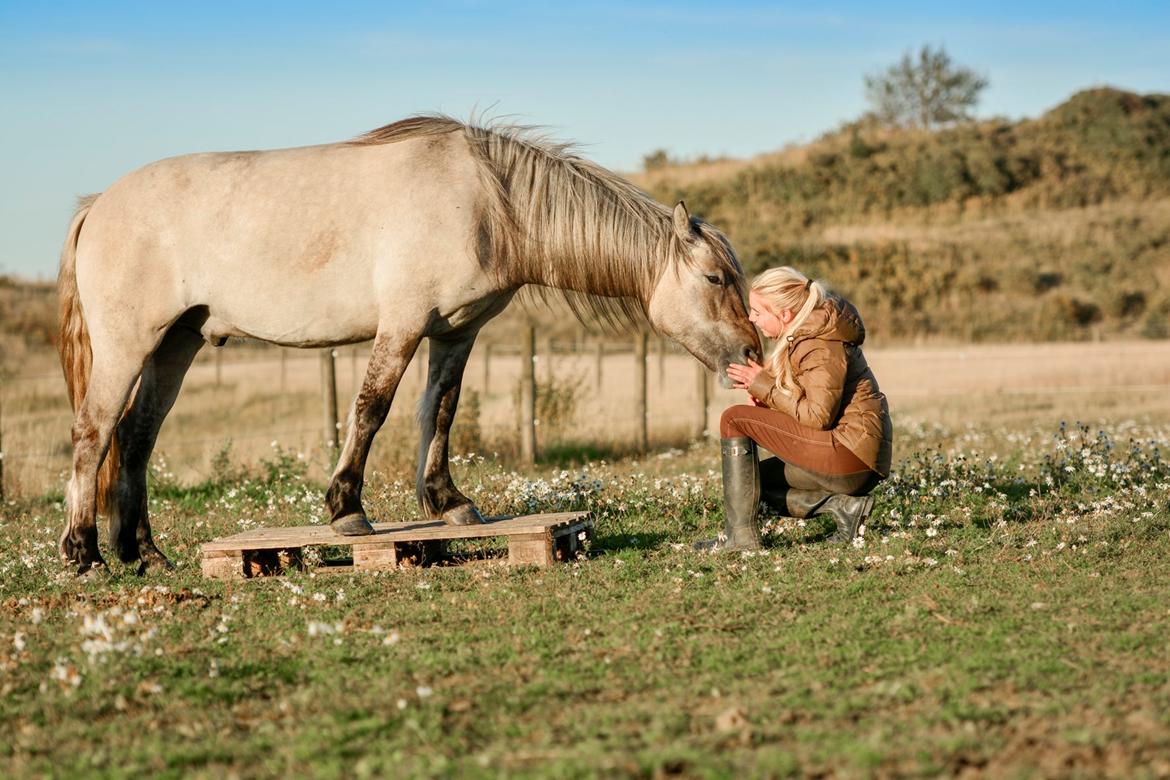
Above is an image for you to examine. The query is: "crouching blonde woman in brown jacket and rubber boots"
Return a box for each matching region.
[696,267,893,550]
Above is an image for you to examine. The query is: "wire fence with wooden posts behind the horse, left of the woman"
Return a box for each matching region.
[0,334,711,497]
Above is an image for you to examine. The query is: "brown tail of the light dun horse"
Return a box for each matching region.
[57,195,122,512]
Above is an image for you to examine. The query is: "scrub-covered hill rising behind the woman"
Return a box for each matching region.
[634,88,1170,340]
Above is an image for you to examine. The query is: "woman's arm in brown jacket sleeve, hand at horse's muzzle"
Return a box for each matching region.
[748,339,847,430]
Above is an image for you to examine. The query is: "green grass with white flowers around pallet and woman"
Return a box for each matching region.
[0,426,1170,776]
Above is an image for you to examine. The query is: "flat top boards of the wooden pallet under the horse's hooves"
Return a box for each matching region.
[202,512,589,553]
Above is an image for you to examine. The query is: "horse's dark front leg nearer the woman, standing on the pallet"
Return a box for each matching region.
[415,333,483,525]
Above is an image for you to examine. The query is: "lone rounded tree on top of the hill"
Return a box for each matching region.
[866,44,987,130]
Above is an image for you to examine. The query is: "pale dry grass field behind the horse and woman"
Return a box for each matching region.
[0,341,1170,496]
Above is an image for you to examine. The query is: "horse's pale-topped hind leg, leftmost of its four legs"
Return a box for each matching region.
[60,348,149,573]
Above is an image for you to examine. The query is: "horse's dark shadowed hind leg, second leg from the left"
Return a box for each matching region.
[110,320,205,573]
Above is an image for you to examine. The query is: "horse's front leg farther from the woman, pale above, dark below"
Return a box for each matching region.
[325,336,419,536]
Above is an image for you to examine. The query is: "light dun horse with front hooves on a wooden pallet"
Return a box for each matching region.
[59,117,759,572]
